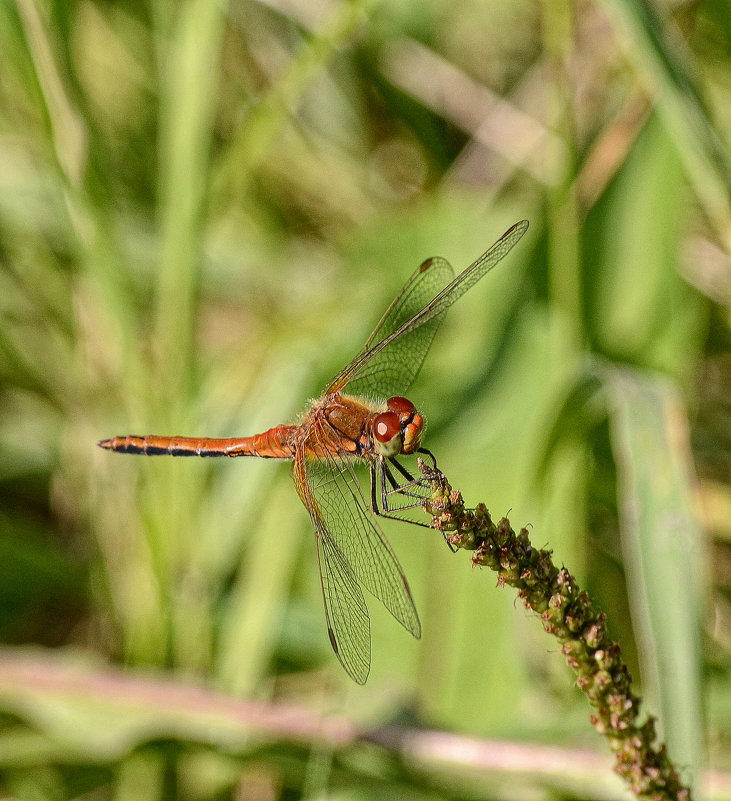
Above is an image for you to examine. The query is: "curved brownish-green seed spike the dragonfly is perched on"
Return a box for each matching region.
[419,460,691,801]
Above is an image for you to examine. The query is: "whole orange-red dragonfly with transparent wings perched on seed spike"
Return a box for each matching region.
[98,220,528,684]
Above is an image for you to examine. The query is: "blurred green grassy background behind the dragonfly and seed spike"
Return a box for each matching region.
[0,0,731,801]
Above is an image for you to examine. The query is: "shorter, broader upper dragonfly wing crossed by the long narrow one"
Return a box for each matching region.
[325,253,454,398]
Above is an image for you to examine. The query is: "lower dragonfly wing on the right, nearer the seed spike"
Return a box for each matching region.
[307,450,421,638]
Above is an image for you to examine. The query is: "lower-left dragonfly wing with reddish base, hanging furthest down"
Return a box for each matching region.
[292,449,371,684]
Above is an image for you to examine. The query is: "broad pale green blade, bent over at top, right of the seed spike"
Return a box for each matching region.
[608,369,705,788]
